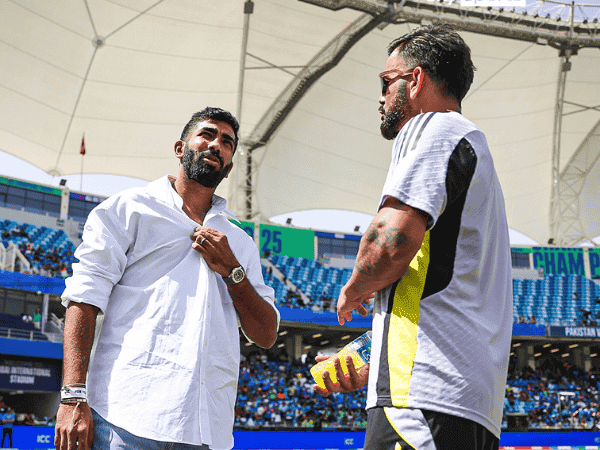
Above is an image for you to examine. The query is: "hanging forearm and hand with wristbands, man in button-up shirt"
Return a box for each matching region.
[54,302,98,450]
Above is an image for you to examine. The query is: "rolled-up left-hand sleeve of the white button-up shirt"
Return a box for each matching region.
[62,201,133,312]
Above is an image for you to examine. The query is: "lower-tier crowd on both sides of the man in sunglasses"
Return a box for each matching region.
[235,355,600,431]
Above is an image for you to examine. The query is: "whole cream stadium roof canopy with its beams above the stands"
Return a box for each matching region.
[0,0,600,245]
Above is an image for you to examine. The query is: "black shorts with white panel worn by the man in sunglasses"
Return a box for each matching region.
[364,407,499,450]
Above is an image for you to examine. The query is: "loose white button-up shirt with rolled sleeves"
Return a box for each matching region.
[62,176,279,450]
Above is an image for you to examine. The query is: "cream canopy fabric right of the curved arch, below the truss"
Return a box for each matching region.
[253,25,600,243]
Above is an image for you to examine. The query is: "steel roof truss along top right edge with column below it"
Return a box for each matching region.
[300,0,600,246]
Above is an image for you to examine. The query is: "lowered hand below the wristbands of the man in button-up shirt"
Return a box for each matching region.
[54,402,94,450]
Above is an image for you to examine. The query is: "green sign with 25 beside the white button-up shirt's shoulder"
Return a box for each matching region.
[259,225,315,259]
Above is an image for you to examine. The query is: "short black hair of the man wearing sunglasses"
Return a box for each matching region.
[388,23,475,105]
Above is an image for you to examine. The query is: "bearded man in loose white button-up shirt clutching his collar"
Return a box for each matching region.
[55,108,279,450]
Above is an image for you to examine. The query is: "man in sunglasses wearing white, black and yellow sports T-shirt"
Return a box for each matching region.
[315,24,512,450]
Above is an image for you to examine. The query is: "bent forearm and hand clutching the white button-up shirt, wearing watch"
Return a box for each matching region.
[191,227,277,348]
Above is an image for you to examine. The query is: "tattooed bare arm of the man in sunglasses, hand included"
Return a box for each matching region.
[337,197,428,325]
